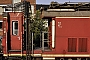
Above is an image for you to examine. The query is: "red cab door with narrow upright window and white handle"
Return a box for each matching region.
[9,12,23,50]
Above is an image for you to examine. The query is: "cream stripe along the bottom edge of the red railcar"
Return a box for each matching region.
[3,54,90,59]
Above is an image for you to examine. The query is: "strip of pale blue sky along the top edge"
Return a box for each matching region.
[36,0,90,4]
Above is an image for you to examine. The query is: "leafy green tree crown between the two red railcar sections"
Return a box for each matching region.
[31,10,46,32]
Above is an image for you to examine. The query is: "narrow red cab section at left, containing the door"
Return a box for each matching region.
[2,12,24,56]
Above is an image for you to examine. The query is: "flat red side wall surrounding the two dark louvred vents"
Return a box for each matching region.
[55,18,90,54]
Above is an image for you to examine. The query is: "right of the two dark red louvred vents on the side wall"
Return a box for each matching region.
[78,38,87,52]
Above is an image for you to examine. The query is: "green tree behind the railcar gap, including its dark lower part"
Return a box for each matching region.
[31,10,47,47]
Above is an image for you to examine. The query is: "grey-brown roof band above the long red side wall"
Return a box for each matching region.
[42,11,90,17]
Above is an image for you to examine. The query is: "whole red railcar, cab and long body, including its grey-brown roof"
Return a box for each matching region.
[2,1,90,60]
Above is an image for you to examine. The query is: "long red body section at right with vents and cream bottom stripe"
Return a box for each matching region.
[34,17,90,57]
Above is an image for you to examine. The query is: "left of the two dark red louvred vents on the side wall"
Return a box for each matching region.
[68,38,77,52]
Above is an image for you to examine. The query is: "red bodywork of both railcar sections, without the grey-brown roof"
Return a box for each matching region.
[2,12,90,58]
